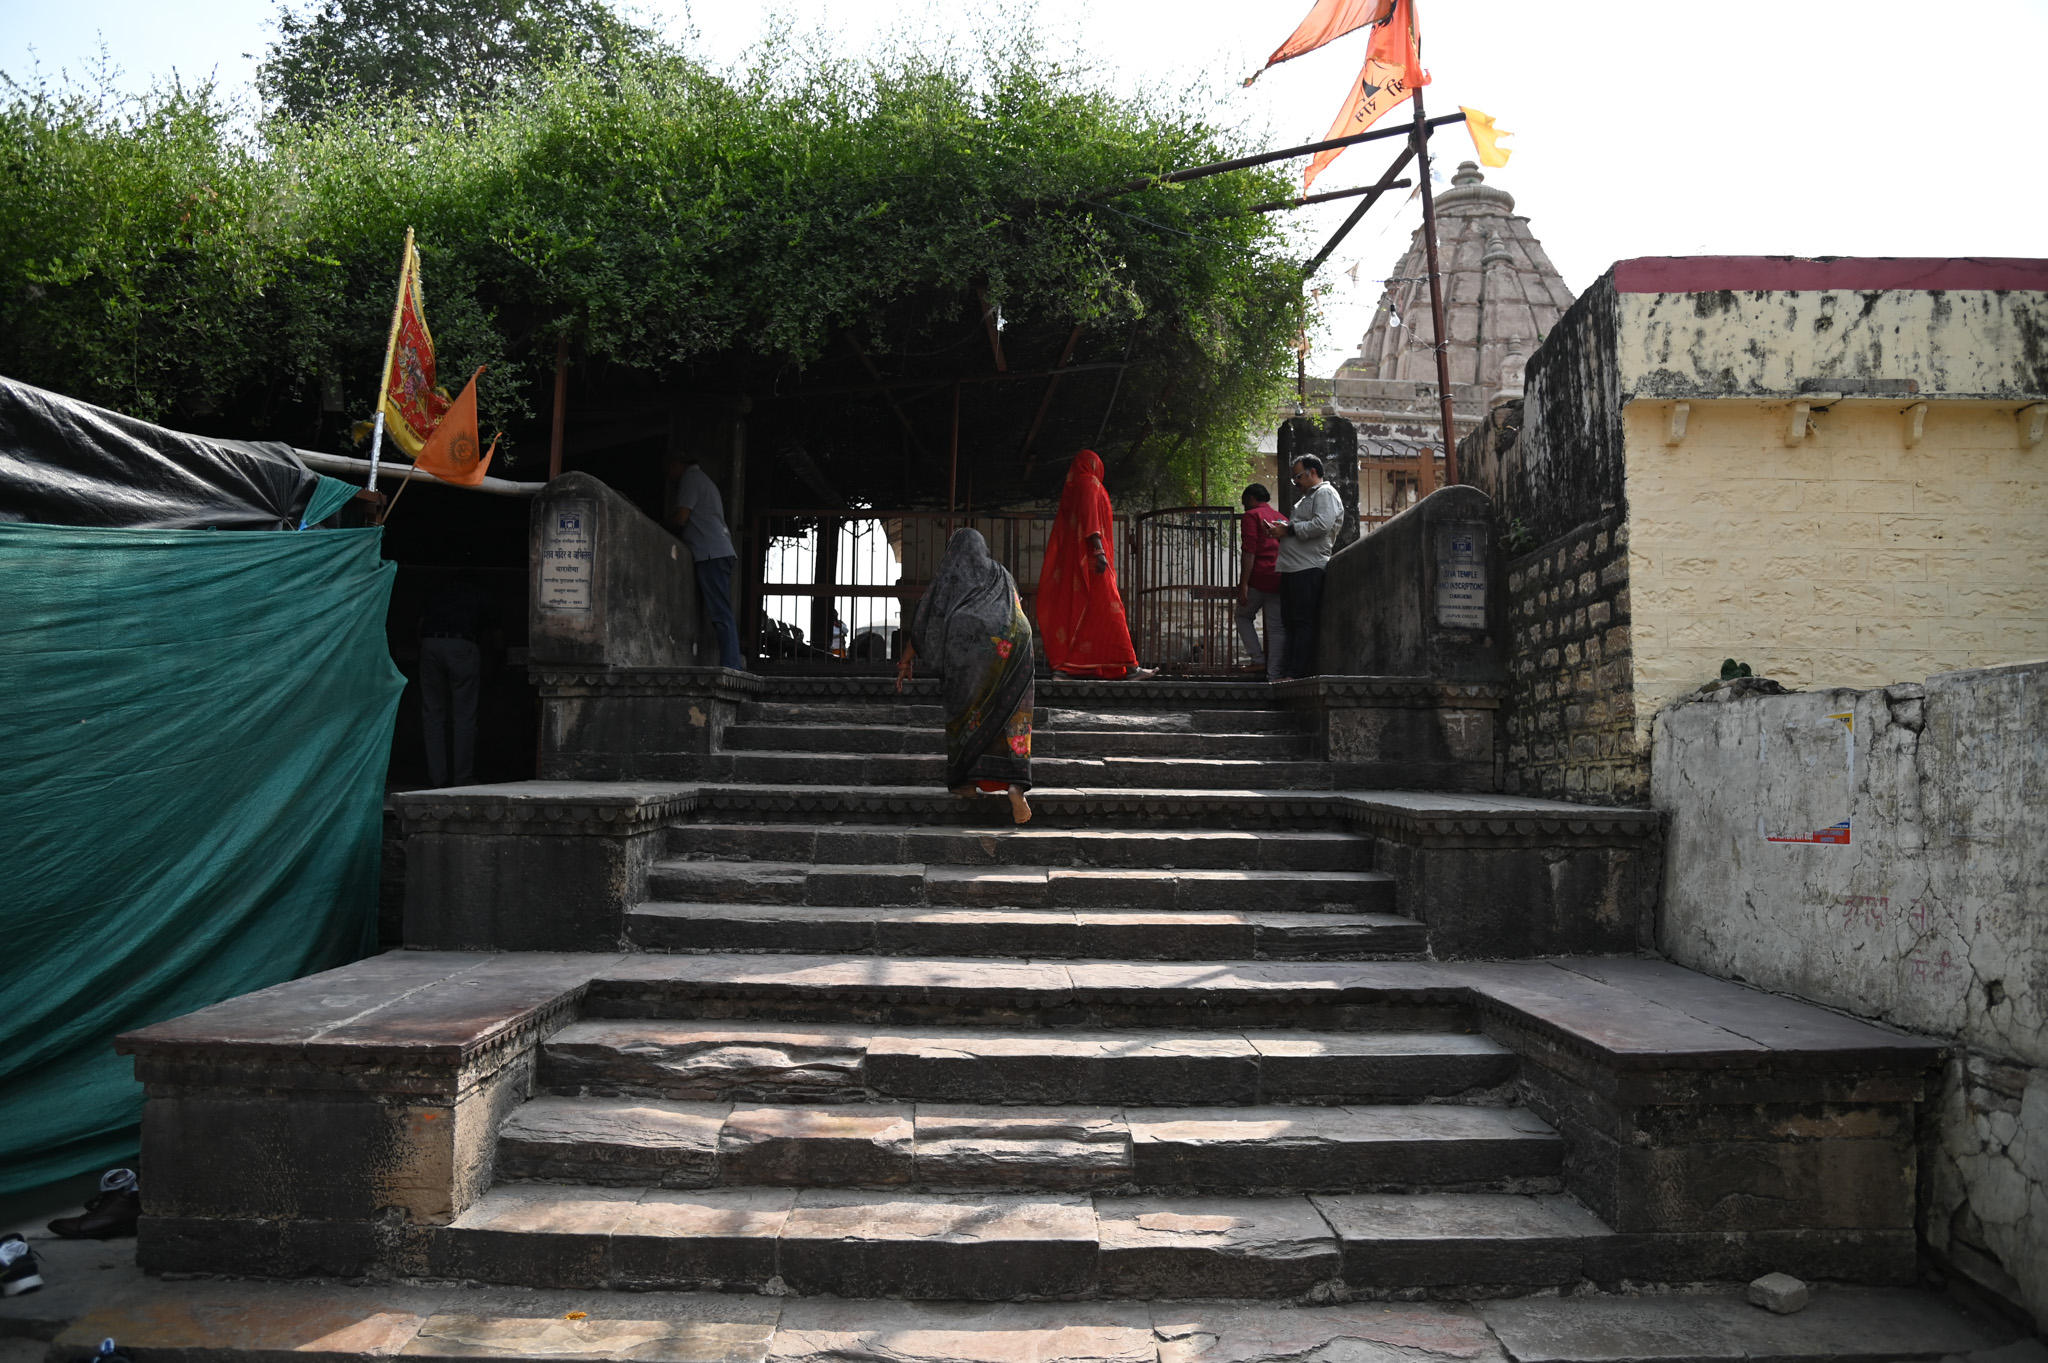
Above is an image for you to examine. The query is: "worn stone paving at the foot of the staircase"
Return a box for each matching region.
[28,1275,2015,1363]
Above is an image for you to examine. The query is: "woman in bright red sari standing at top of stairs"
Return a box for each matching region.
[1038,450,1153,682]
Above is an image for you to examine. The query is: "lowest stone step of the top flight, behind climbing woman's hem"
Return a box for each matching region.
[719,749,1335,790]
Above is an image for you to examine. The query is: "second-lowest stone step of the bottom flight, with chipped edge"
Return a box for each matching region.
[496,1097,1565,1191]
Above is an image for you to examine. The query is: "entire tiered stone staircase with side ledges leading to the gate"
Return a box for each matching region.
[125,682,1937,1302]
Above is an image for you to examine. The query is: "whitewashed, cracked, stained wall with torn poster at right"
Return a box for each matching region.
[1653,663,2048,1324]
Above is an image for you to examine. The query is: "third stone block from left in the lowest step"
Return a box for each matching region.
[1096,1197,1337,1298]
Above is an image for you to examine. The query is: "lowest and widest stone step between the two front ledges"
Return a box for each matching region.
[428,1183,1612,1293]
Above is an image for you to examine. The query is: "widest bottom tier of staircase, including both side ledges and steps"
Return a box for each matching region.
[121,952,1942,1300]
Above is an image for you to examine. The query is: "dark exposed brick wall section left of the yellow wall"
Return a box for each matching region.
[1505,510,1649,804]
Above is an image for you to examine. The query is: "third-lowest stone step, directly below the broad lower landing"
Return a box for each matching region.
[539,1017,1518,1107]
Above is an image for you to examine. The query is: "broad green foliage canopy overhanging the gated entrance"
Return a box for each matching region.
[0,26,1303,501]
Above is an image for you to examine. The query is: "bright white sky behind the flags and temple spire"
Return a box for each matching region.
[12,0,2048,375]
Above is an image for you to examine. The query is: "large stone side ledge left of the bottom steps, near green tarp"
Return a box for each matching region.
[115,952,610,1236]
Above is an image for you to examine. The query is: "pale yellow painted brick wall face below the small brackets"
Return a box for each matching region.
[1624,399,2048,737]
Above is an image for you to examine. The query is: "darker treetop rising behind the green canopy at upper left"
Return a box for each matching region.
[256,0,655,123]
